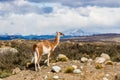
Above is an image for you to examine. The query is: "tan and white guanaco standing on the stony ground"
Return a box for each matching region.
[33,32,64,71]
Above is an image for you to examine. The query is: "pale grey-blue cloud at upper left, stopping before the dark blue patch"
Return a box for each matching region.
[0,1,41,15]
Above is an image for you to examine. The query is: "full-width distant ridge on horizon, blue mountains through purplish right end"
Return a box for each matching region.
[0,29,120,41]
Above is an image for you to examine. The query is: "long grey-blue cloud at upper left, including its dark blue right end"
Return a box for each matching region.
[0,1,53,16]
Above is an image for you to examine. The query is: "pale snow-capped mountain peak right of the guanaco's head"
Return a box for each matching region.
[63,29,95,36]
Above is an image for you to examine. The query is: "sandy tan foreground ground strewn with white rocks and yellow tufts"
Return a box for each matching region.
[3,55,120,80]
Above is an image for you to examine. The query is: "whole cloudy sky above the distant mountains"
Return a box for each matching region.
[0,0,120,35]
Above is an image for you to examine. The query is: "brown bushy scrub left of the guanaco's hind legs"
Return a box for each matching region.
[0,40,33,75]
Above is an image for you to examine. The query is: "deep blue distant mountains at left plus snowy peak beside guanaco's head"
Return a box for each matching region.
[0,29,93,40]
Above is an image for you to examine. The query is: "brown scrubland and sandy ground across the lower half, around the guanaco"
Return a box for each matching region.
[0,40,120,80]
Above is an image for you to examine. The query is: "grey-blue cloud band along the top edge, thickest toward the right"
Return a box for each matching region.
[27,0,120,7]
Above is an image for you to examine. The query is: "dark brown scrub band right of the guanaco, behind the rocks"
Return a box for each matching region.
[54,42,120,61]
